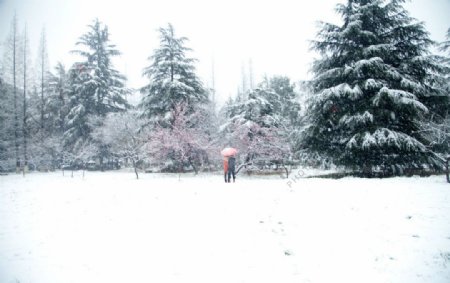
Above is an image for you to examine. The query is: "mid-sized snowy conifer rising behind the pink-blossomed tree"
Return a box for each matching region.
[139,24,208,124]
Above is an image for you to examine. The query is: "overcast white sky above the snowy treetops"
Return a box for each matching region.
[0,0,450,105]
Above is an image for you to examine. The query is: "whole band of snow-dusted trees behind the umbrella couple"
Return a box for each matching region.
[0,0,450,177]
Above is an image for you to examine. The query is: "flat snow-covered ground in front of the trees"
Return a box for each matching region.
[0,172,450,283]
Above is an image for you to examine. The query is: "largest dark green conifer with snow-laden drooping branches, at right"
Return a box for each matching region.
[303,0,442,173]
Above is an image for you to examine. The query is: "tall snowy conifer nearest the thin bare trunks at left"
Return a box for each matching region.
[64,19,129,153]
